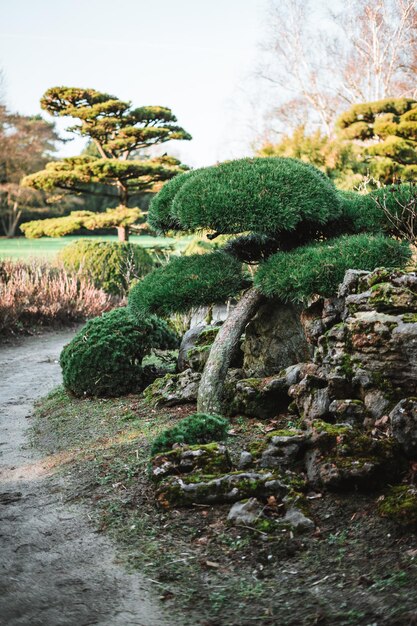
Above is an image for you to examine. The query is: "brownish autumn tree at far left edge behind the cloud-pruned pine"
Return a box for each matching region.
[0,105,60,237]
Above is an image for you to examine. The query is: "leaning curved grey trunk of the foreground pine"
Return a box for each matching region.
[197,287,264,414]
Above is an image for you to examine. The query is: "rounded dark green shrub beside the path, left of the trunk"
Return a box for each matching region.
[60,308,178,397]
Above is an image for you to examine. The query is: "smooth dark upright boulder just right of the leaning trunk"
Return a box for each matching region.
[243,301,311,377]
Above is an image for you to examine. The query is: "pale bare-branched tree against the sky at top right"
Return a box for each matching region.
[260,0,417,135]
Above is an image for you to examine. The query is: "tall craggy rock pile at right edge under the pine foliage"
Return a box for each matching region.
[289,269,417,425]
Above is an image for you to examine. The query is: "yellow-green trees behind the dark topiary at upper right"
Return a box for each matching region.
[257,98,417,189]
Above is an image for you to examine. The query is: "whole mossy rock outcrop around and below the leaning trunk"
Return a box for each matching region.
[145,269,417,532]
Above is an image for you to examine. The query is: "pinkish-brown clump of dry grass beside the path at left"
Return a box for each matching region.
[0,260,115,334]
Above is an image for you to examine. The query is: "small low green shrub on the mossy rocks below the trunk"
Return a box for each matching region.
[151,413,230,456]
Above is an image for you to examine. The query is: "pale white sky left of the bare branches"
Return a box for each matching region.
[0,0,268,167]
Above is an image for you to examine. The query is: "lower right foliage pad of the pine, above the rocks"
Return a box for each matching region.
[255,235,411,302]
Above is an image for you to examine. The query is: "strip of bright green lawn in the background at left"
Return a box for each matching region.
[0,235,190,260]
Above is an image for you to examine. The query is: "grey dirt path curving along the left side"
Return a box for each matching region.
[0,331,173,626]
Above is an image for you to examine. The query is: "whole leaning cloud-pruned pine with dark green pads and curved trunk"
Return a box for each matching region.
[129,158,410,413]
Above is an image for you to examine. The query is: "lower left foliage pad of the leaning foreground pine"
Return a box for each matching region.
[129,252,248,316]
